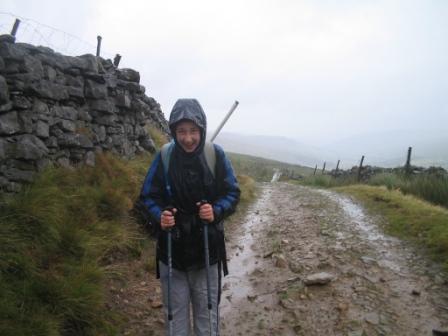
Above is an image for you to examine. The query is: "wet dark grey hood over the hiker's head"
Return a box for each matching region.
[168,98,207,152]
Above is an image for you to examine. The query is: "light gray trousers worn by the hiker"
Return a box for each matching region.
[159,262,219,336]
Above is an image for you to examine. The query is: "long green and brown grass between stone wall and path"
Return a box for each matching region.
[0,150,255,336]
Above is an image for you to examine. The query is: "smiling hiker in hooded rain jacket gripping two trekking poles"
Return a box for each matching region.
[141,99,240,336]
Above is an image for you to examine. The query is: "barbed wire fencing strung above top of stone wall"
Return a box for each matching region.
[0,11,115,59]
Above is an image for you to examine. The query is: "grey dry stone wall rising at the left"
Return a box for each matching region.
[0,35,168,192]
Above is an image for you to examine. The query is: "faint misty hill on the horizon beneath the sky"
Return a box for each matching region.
[216,131,448,169]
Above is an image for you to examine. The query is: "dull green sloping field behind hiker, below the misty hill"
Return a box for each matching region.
[227,153,314,181]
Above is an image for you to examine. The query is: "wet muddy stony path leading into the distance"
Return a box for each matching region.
[221,183,448,336]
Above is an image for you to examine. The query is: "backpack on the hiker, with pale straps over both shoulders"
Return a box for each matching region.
[131,141,216,237]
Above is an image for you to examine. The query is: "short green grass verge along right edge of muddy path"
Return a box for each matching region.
[335,185,448,270]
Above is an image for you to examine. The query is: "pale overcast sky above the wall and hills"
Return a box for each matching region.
[0,0,448,143]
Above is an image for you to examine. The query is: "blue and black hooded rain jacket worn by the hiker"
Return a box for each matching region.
[141,99,240,274]
